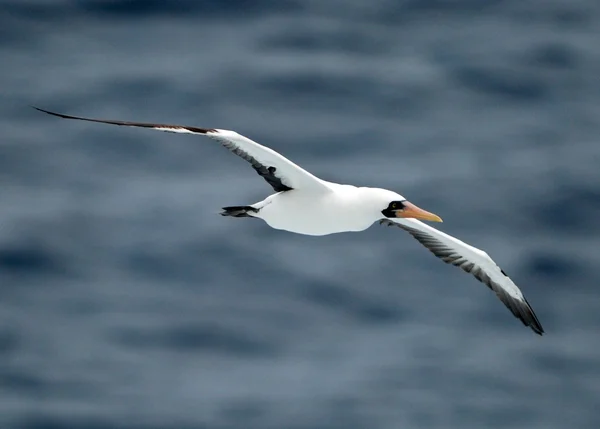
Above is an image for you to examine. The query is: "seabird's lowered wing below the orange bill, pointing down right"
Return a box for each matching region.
[380,218,544,335]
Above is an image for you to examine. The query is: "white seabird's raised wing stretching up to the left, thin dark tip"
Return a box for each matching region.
[34,107,329,192]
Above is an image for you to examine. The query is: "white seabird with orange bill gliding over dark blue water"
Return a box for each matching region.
[32,106,544,335]
